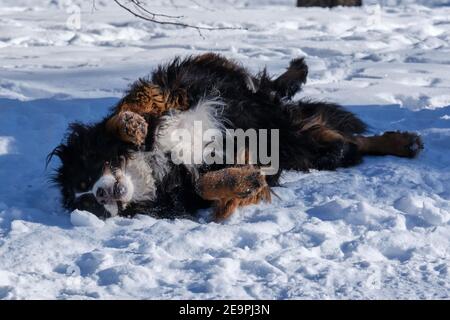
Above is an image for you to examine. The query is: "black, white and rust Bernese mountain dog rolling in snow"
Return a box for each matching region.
[48,53,423,221]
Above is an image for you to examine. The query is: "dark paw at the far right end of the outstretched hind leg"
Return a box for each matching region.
[383,131,424,158]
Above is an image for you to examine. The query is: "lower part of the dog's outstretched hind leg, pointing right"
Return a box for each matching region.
[353,131,424,158]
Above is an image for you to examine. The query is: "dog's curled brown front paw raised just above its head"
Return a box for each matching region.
[117,111,148,146]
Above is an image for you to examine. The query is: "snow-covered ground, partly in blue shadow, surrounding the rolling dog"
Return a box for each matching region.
[0,0,450,299]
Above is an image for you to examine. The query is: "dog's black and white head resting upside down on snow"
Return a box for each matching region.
[48,123,139,218]
